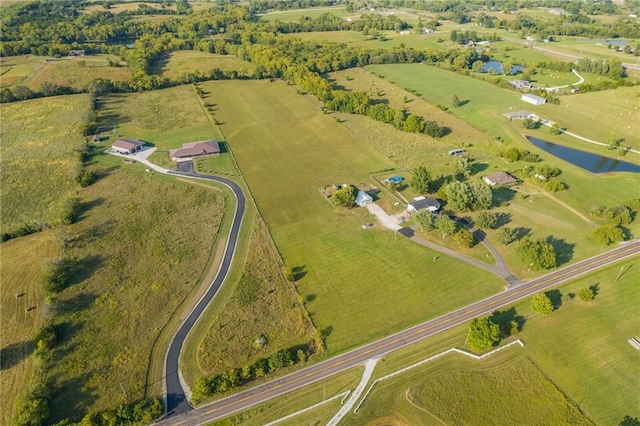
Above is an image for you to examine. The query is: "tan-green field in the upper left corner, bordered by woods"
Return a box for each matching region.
[1,55,131,92]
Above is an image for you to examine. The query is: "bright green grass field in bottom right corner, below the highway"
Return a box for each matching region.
[516,257,640,424]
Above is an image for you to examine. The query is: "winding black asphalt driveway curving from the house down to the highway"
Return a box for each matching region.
[164,172,245,421]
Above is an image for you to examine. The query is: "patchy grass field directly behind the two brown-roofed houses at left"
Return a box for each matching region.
[98,85,222,151]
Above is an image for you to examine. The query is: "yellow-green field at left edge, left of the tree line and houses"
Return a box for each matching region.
[0,95,89,238]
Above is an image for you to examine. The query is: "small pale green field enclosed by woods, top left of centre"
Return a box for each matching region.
[151,50,255,79]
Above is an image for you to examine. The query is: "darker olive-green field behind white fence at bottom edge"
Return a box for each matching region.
[344,354,593,425]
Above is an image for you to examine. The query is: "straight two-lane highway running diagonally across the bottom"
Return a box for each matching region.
[160,240,640,425]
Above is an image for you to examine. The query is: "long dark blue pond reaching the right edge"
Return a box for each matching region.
[526,136,640,173]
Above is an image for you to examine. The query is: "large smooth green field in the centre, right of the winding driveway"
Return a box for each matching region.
[203,81,502,351]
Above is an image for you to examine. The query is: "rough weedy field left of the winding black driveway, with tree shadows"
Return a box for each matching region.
[45,165,224,422]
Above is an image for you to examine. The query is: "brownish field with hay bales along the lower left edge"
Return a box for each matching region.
[0,232,60,425]
